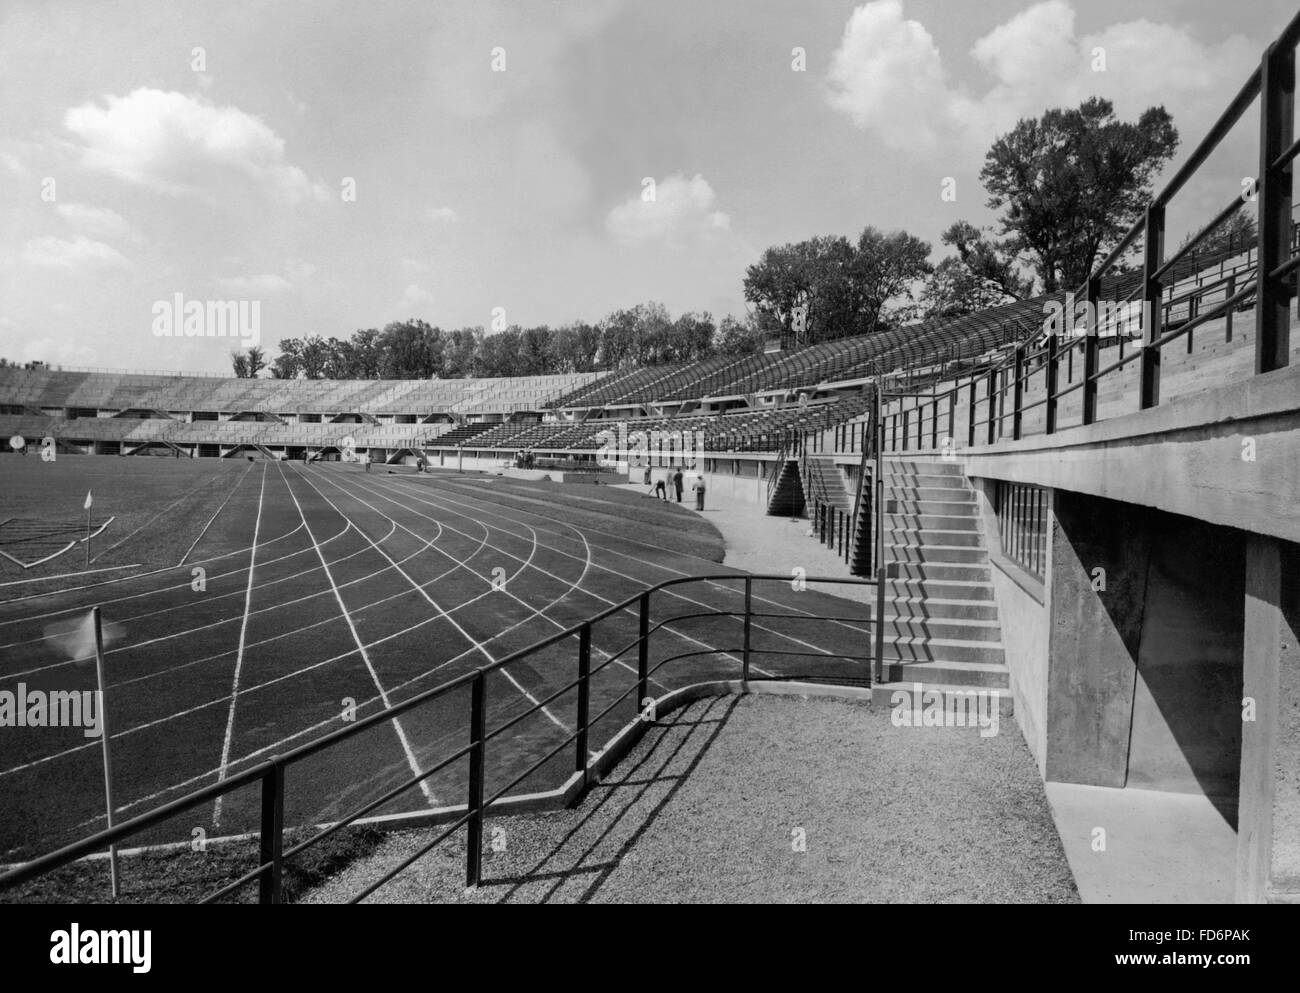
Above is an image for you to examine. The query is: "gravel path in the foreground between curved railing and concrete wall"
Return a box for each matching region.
[308,697,1079,903]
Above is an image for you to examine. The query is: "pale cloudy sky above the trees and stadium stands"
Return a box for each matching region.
[0,0,1295,373]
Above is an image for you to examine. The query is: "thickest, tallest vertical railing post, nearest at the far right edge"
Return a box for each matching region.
[1255,42,1296,374]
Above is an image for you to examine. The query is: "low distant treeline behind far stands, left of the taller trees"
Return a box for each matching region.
[230,303,762,380]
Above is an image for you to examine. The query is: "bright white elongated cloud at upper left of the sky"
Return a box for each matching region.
[64,88,329,203]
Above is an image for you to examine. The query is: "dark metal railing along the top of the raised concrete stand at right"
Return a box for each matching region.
[884,14,1300,451]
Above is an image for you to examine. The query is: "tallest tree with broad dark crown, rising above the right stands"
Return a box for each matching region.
[980,97,1178,292]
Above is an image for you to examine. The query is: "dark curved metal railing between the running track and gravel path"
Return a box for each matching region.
[0,573,883,903]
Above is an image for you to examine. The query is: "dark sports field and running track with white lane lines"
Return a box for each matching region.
[0,456,868,899]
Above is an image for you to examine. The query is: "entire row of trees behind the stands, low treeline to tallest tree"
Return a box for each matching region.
[233,97,1196,378]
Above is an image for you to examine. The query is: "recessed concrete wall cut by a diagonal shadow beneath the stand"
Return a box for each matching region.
[1047,491,1245,800]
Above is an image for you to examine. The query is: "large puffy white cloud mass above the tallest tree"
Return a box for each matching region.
[826,0,1257,156]
